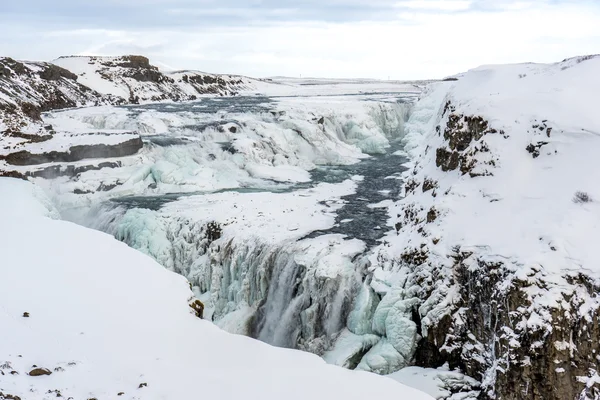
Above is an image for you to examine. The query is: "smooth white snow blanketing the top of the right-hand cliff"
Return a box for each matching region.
[390,58,600,282]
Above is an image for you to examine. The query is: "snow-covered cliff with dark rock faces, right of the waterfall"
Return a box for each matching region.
[359,57,600,399]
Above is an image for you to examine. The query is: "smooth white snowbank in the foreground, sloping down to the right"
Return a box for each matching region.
[0,178,431,400]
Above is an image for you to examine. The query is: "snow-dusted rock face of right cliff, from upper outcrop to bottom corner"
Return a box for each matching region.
[378,83,600,400]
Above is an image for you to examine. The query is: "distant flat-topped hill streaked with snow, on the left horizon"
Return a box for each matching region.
[53,56,251,103]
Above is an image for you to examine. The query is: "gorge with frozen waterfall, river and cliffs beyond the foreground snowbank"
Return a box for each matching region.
[0,56,600,400]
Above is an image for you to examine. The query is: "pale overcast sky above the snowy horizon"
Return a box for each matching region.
[0,0,600,79]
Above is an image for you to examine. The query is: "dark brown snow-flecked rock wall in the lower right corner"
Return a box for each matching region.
[413,248,600,400]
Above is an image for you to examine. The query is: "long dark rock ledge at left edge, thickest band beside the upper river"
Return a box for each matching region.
[4,137,143,165]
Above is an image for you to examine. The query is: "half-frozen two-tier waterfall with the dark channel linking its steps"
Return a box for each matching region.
[47,94,412,365]
